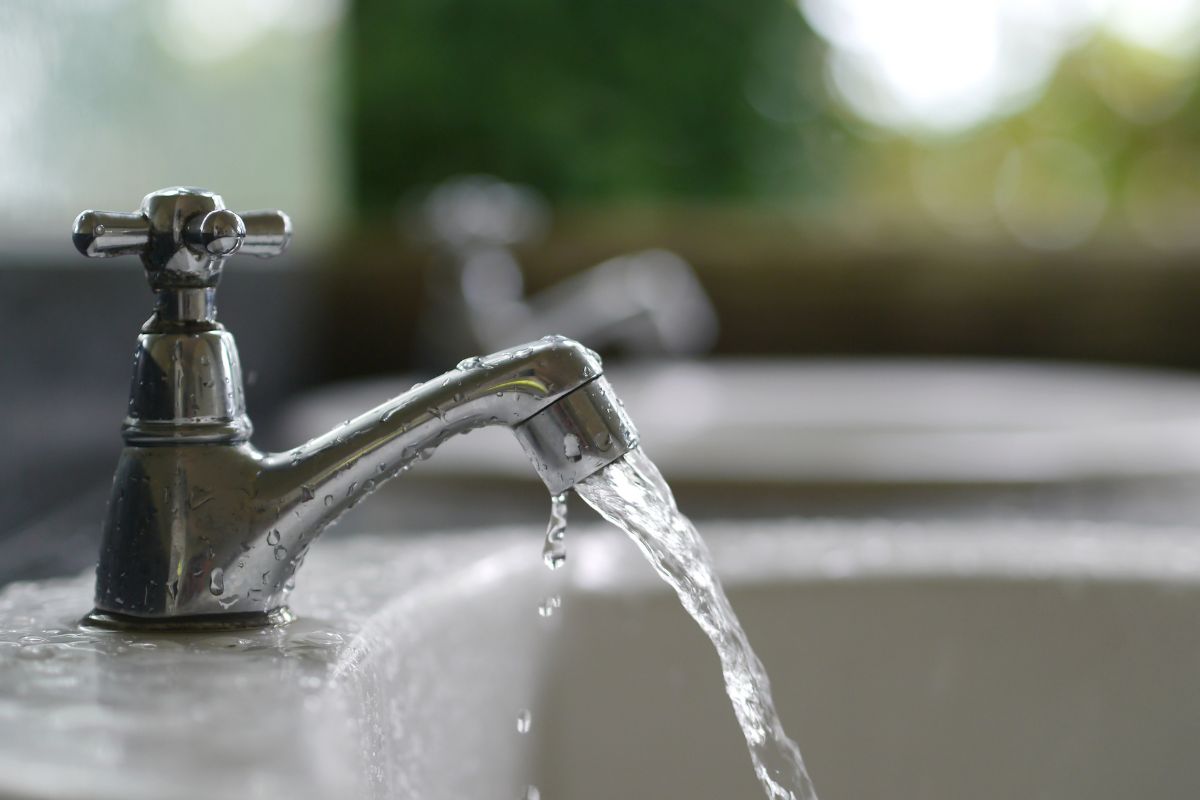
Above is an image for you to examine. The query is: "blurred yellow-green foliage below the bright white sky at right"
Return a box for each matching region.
[828,31,1200,250]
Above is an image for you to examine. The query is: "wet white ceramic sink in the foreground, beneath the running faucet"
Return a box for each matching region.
[0,522,1200,800]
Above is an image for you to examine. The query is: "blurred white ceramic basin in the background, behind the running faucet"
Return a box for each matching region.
[282,360,1200,485]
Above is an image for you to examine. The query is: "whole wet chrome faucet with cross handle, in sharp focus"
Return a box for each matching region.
[74,187,637,628]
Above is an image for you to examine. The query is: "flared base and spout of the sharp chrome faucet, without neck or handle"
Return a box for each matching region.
[90,336,637,627]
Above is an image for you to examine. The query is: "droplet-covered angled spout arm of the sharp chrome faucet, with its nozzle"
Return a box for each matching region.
[258,337,636,541]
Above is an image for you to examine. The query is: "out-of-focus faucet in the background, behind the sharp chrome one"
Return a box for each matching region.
[418,175,716,363]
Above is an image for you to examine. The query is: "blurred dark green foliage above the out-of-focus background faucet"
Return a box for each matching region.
[348,0,830,212]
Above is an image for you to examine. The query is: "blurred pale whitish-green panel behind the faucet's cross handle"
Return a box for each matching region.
[0,0,347,257]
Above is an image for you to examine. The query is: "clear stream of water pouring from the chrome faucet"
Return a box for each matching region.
[575,447,817,800]
